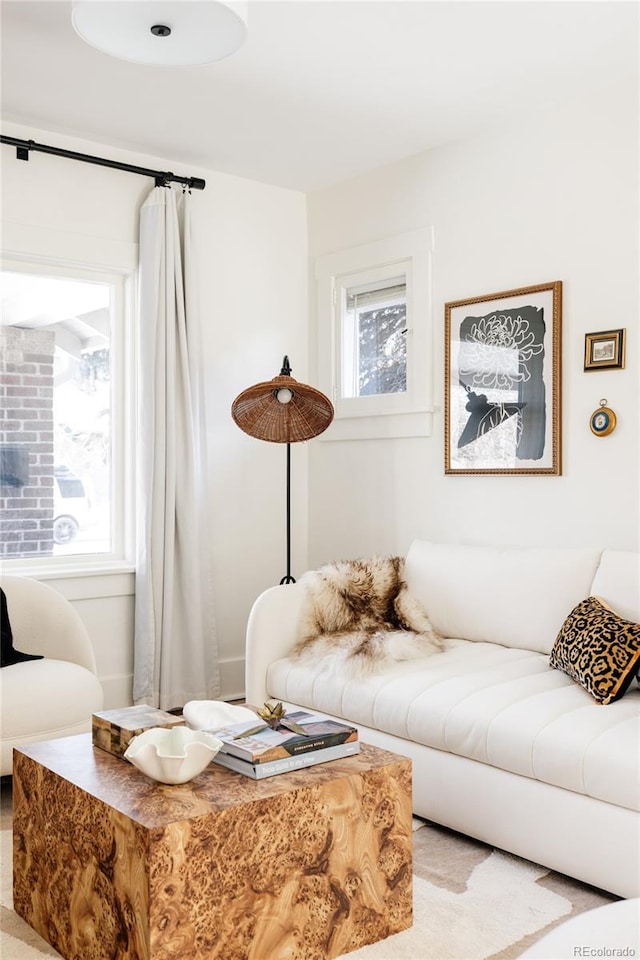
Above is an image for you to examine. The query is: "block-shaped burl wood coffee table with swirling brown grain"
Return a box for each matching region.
[13,735,412,960]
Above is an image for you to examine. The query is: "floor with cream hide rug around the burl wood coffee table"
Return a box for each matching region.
[0,782,616,960]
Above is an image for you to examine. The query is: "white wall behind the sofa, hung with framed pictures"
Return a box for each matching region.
[308,84,640,566]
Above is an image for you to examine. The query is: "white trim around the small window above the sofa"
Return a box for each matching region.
[315,228,434,442]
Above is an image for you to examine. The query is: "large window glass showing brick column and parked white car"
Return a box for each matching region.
[0,262,131,561]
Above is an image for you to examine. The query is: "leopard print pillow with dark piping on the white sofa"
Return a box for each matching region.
[549,597,640,704]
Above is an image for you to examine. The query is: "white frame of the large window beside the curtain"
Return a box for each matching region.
[0,250,135,579]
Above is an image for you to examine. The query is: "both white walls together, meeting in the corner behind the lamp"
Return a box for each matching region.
[1,73,640,707]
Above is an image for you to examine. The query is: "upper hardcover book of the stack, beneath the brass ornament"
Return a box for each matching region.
[216,710,358,764]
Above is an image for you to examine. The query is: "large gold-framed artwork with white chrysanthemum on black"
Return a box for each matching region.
[445,280,562,476]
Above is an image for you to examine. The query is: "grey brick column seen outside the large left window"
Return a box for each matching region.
[0,327,55,557]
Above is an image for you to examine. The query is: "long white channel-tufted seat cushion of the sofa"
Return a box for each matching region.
[267,639,640,809]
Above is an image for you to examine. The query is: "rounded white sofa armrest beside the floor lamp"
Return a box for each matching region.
[245,583,307,707]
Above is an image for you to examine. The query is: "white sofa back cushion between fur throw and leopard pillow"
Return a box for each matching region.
[405,540,601,654]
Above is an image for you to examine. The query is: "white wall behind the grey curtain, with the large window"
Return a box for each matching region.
[1,123,307,708]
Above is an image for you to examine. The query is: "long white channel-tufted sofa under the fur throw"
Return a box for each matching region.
[246,540,640,897]
